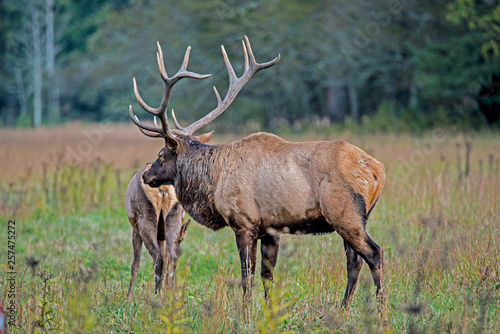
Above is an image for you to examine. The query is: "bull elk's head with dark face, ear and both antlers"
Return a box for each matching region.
[129,36,280,187]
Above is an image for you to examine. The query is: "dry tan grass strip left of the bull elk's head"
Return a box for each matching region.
[0,123,163,178]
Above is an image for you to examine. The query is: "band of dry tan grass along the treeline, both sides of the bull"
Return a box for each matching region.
[0,123,500,180]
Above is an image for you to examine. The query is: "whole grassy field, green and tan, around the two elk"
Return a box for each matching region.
[0,124,500,333]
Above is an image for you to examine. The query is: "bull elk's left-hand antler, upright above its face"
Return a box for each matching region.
[129,42,211,140]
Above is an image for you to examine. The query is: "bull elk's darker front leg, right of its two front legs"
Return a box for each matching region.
[260,234,280,301]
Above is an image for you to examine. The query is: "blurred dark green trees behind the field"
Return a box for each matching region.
[0,0,500,131]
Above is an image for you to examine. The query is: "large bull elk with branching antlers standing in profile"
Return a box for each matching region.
[129,36,385,306]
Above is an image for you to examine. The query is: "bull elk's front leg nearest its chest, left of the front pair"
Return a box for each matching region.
[236,230,257,301]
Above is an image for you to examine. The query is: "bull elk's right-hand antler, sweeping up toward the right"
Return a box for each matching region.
[176,36,280,135]
